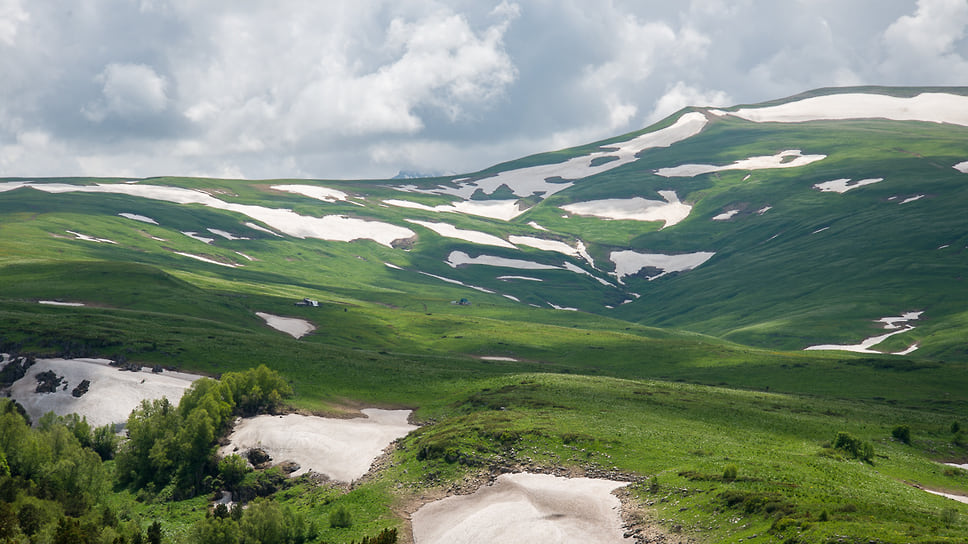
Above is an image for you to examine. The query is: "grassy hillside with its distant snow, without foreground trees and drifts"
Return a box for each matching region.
[0,87,968,542]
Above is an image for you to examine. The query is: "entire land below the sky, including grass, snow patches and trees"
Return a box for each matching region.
[0,87,968,544]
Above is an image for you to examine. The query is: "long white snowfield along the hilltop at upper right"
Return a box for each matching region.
[727,93,968,126]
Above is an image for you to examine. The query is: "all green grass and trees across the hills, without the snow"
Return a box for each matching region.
[0,85,968,543]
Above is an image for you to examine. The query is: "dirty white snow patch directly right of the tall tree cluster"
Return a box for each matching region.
[219,408,417,482]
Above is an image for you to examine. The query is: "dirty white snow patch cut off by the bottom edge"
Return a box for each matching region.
[411,473,629,544]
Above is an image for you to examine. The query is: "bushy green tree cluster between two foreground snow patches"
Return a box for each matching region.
[117,365,292,499]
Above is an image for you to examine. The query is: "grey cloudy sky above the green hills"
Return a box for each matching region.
[0,0,968,179]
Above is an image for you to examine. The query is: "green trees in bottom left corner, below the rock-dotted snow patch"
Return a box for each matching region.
[0,399,161,544]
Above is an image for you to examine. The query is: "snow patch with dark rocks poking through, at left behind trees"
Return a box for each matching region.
[4,359,201,426]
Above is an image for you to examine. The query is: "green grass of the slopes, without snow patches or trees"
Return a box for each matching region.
[0,87,968,542]
